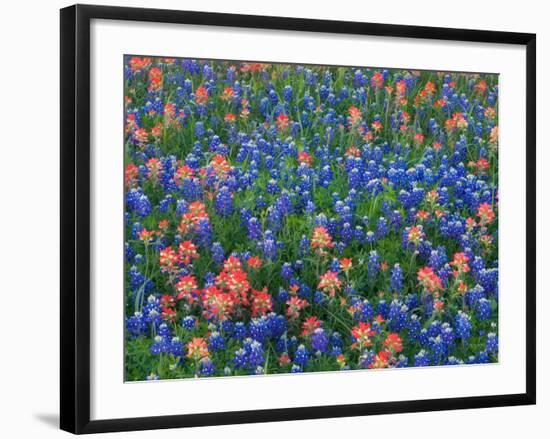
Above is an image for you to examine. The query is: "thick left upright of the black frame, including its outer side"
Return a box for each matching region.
[60,5,90,434]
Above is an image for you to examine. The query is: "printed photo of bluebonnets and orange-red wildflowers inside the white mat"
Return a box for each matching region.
[124,56,498,380]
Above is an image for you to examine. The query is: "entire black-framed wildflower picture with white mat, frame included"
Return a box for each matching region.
[61,5,536,433]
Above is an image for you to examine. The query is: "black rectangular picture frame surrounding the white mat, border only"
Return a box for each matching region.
[60,5,536,434]
